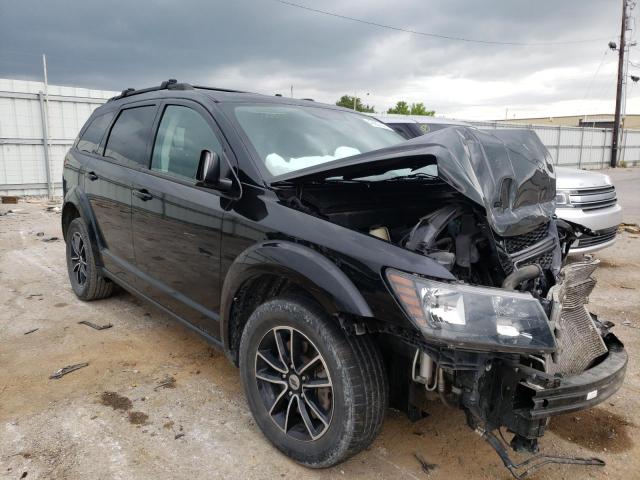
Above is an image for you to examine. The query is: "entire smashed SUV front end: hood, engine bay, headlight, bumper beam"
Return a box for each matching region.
[275,127,627,476]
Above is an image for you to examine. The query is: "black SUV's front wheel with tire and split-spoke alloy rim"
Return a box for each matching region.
[240,297,388,468]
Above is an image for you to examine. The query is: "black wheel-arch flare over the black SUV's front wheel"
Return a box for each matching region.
[220,241,373,348]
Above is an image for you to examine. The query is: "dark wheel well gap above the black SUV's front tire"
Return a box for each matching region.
[228,274,316,366]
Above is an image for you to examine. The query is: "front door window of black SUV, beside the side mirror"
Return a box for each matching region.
[151,105,222,178]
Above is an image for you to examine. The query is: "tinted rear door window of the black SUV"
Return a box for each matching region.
[104,106,156,165]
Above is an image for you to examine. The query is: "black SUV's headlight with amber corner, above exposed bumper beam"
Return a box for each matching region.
[386,269,556,352]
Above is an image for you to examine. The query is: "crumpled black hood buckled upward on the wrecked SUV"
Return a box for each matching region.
[270,126,556,236]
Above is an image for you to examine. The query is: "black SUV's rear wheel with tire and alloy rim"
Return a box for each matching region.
[65,217,113,301]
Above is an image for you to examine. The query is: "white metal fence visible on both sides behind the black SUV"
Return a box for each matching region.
[0,79,640,195]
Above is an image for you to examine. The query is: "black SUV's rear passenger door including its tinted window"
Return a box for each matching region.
[78,104,157,282]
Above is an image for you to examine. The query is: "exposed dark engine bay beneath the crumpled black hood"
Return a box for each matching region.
[280,178,571,299]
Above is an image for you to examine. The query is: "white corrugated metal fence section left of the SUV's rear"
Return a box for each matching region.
[0,79,117,195]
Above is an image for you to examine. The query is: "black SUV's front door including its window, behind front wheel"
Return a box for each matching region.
[132,100,229,338]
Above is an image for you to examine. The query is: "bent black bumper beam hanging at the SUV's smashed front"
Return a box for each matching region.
[528,337,628,420]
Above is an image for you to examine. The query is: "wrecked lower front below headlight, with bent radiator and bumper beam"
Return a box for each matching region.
[412,260,627,478]
